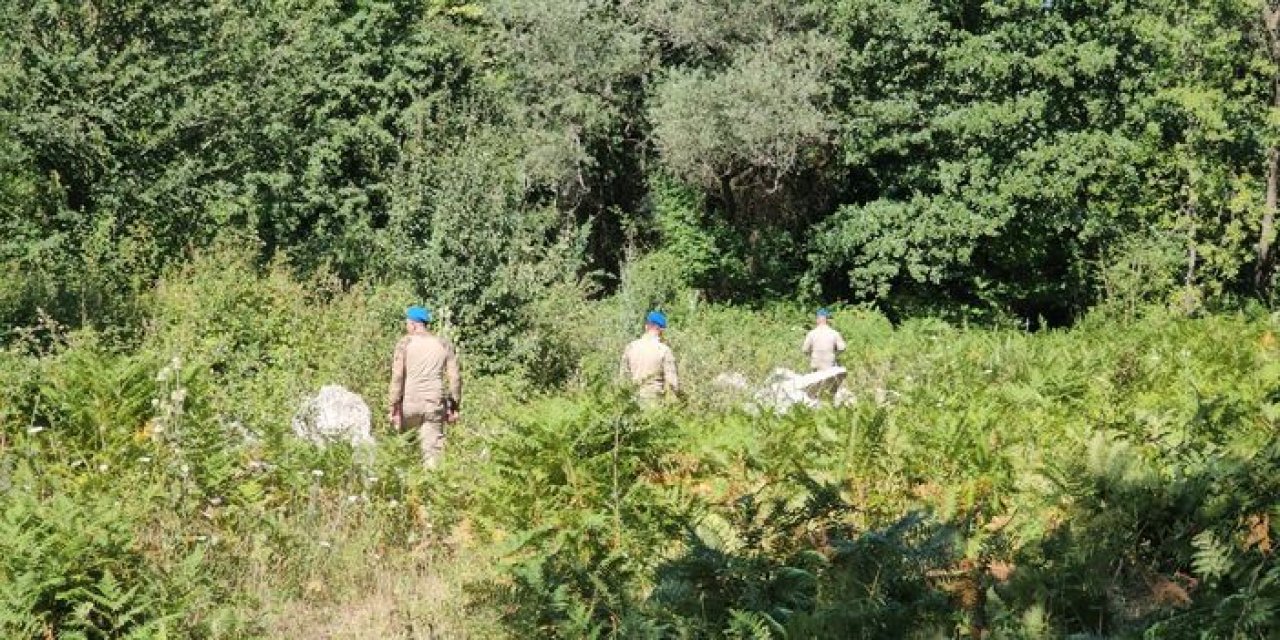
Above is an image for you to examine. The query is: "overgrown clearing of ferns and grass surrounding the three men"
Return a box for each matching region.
[0,253,1280,639]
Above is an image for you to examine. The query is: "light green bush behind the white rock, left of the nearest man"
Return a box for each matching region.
[141,241,415,438]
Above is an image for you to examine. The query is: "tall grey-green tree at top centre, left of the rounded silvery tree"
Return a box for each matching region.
[490,0,657,271]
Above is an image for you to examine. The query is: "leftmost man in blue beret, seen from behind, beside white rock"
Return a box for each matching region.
[388,306,462,468]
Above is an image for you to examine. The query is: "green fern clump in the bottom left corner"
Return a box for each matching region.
[0,465,212,639]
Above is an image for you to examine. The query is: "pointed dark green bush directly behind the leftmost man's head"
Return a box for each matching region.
[388,129,584,372]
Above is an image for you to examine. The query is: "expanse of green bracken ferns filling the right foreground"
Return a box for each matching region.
[465,305,1280,637]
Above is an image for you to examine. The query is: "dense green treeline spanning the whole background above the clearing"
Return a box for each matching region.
[0,0,1280,353]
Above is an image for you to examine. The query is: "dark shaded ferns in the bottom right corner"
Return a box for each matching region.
[993,434,1280,637]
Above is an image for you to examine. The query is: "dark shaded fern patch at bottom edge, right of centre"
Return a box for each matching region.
[648,474,956,637]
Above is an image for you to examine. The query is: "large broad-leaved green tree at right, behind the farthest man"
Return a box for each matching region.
[813,0,1261,321]
